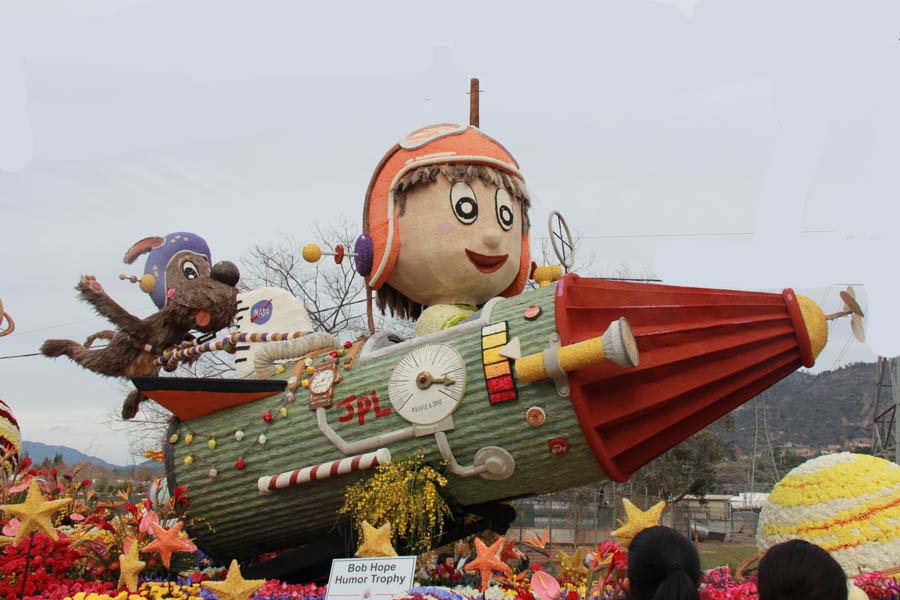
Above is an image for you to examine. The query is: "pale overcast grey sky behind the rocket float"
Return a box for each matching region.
[0,0,900,463]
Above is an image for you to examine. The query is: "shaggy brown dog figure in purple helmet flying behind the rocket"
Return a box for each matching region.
[41,232,240,419]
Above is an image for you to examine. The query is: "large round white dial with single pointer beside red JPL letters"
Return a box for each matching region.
[388,344,466,425]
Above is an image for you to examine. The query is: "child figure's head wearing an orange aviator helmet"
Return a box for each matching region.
[363,124,531,318]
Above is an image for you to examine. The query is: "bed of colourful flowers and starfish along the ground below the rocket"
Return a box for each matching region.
[0,459,900,600]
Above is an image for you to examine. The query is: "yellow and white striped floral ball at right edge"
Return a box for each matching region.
[756,452,900,577]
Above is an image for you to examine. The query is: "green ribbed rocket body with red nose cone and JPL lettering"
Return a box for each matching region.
[142,275,827,558]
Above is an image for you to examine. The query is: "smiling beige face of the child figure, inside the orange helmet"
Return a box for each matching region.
[388,176,523,306]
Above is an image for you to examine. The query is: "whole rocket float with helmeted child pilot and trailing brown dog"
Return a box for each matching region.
[31,95,868,575]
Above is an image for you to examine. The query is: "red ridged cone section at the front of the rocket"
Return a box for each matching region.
[556,275,810,481]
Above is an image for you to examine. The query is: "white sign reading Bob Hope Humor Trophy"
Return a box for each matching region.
[325,556,416,600]
